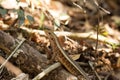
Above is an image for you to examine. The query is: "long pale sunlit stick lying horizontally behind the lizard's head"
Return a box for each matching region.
[21,27,119,44]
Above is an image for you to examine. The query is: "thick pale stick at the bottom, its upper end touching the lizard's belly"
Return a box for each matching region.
[32,62,61,80]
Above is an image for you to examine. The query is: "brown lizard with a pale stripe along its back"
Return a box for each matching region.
[44,30,90,80]
